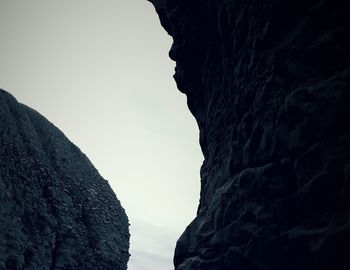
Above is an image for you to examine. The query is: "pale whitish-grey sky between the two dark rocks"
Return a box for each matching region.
[0,0,202,270]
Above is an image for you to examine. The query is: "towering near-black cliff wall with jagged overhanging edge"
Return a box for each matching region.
[152,0,350,270]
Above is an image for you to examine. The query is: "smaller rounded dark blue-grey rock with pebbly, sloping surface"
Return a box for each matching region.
[0,90,129,270]
